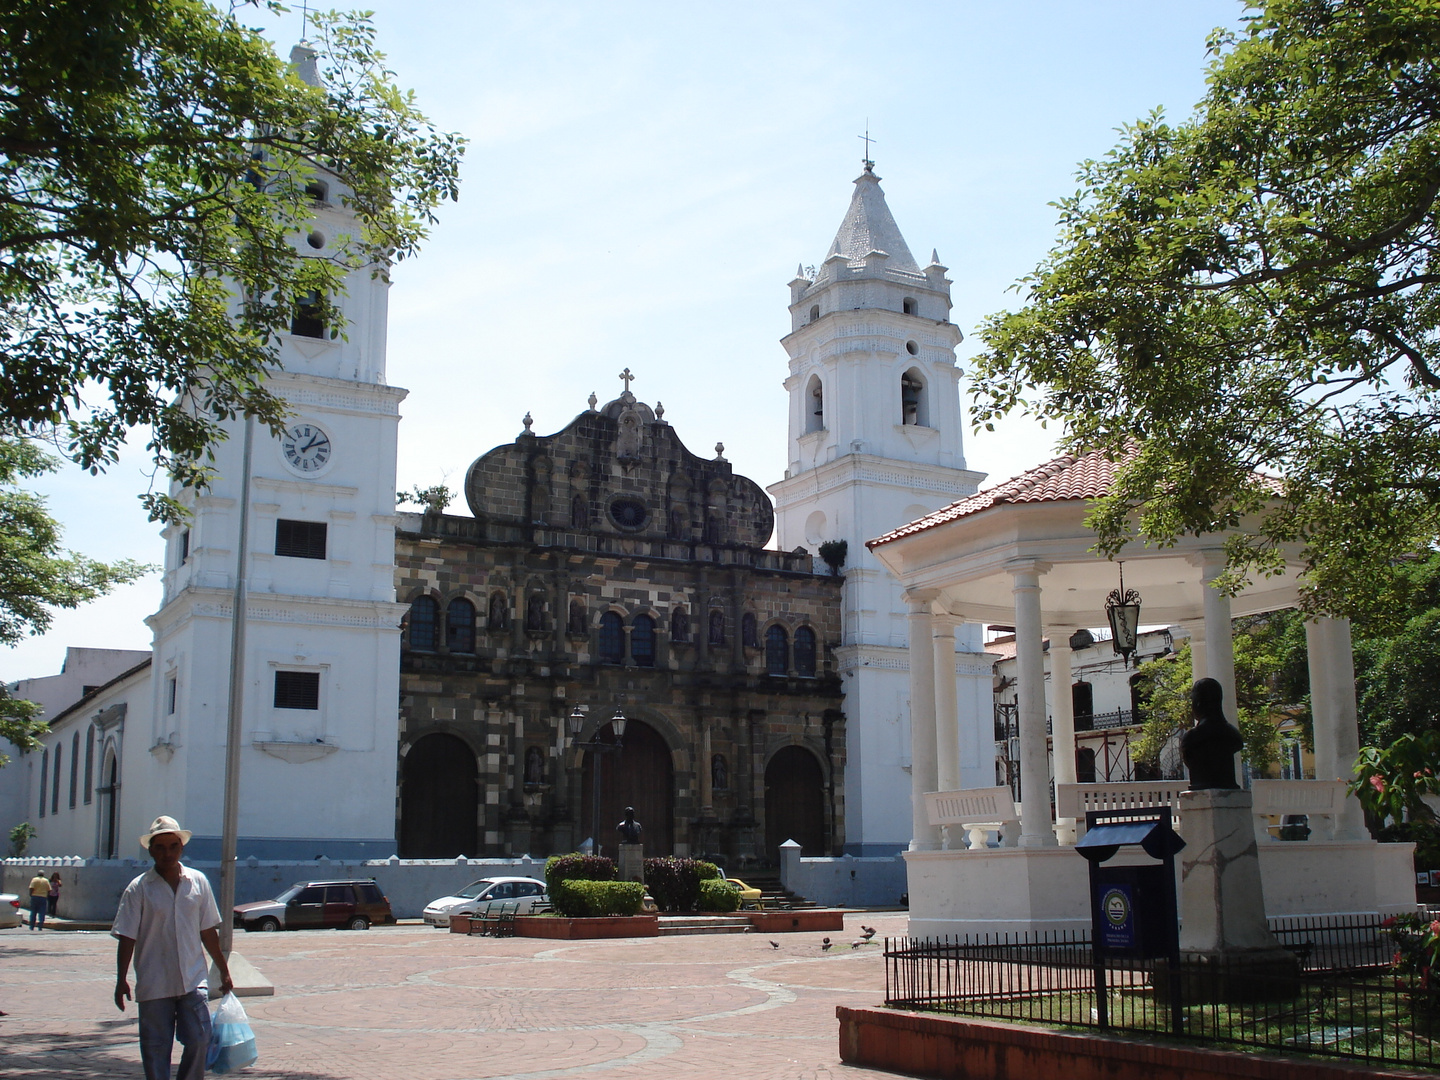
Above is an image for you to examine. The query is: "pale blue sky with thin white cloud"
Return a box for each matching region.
[0,0,1243,681]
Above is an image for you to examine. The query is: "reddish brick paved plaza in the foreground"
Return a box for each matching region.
[0,914,904,1080]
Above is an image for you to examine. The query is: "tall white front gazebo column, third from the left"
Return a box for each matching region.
[1005,559,1056,848]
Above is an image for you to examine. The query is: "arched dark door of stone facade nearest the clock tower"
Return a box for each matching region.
[400,734,480,858]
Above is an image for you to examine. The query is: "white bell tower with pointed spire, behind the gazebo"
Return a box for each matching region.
[769,160,995,855]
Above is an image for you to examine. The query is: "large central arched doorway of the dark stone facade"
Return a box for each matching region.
[580,720,675,858]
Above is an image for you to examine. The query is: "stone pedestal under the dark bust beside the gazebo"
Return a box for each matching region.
[1179,789,1299,1001]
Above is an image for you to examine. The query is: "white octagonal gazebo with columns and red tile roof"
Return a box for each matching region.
[867,454,1416,937]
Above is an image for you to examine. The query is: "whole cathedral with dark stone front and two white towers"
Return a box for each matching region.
[4,122,995,865]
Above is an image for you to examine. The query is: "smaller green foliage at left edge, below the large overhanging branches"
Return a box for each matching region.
[0,438,150,766]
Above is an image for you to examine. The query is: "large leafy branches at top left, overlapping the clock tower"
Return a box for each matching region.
[0,0,462,518]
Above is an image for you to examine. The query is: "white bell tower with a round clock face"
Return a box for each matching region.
[140,45,406,860]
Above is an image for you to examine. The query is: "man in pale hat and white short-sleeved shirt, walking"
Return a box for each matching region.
[111,815,232,1080]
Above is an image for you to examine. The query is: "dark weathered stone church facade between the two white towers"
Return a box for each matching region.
[396,385,845,865]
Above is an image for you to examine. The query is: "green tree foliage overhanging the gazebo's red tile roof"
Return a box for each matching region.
[973,0,1440,615]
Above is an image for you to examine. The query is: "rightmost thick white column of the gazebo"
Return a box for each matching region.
[1305,619,1371,841]
